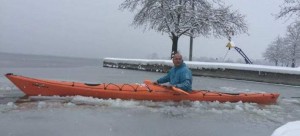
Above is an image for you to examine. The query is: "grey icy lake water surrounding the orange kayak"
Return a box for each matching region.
[0,55,300,136]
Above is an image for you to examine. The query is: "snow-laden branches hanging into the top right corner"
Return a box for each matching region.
[276,0,300,19]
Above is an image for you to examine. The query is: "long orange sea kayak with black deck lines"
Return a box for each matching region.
[5,73,279,104]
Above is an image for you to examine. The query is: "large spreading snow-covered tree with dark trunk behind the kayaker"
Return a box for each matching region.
[120,0,247,58]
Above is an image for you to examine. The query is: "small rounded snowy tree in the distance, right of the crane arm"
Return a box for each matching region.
[263,36,288,66]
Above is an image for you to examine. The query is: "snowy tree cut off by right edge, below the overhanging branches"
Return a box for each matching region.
[286,22,300,67]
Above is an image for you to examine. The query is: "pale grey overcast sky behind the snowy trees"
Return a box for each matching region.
[0,0,289,59]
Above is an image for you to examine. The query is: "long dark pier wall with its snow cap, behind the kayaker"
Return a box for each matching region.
[103,58,300,86]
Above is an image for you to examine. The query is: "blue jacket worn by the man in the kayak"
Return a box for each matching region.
[157,63,192,91]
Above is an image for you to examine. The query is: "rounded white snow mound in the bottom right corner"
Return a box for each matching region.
[272,121,300,136]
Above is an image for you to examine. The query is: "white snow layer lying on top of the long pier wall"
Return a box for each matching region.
[104,58,300,75]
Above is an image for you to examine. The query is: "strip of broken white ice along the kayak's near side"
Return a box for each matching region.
[7,96,278,114]
